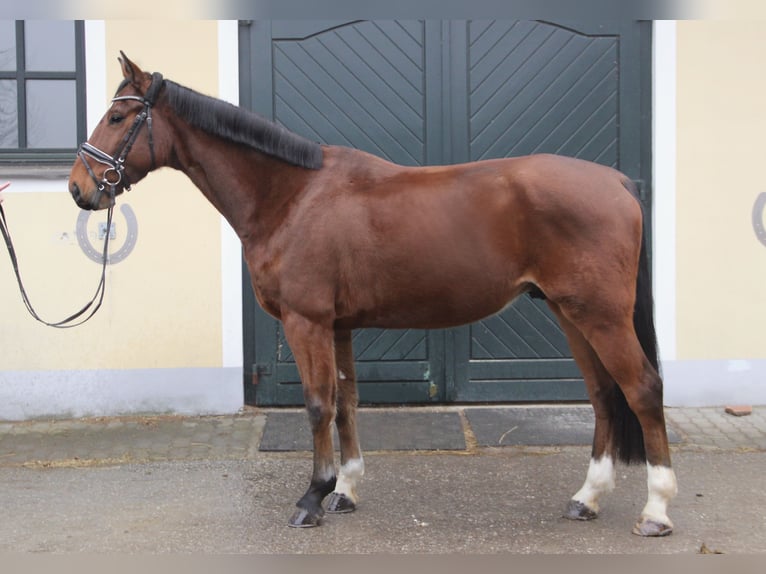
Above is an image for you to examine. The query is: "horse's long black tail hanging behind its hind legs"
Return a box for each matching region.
[612,178,660,464]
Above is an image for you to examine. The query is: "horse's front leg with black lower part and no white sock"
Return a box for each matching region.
[283,314,336,528]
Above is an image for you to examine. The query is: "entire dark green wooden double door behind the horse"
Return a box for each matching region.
[240,21,649,405]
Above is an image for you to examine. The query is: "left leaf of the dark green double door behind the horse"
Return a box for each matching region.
[244,21,444,404]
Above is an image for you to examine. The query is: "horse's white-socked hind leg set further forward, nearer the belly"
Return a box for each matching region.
[548,308,619,520]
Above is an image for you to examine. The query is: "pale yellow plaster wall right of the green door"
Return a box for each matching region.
[676,20,766,360]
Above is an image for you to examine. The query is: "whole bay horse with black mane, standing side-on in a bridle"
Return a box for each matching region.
[69,52,677,536]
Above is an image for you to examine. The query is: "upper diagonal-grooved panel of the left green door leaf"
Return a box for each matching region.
[272,22,425,165]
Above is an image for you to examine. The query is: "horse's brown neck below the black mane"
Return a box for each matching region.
[176,128,314,245]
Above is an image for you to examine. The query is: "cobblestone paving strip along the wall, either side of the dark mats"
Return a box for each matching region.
[0,406,766,467]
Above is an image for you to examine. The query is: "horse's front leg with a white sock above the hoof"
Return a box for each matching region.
[327,331,364,513]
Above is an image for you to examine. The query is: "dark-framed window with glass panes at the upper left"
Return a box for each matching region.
[0,20,87,165]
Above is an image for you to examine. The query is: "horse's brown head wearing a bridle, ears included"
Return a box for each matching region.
[69,52,165,210]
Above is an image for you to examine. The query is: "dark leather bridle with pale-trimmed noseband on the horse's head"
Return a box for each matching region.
[77,72,164,207]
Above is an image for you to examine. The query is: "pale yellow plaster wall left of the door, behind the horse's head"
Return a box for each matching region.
[0,20,222,371]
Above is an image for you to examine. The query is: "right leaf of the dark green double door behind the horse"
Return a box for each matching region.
[453,21,643,401]
